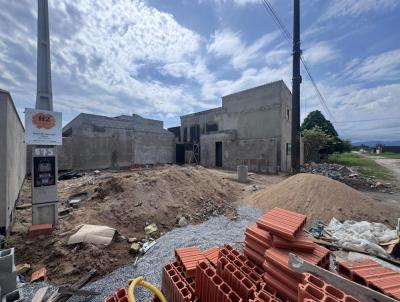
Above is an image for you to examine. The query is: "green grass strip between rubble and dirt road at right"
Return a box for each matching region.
[329,152,394,180]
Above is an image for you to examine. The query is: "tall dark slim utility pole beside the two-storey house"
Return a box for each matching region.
[291,0,301,174]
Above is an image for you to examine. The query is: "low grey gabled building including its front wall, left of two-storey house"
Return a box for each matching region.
[58,113,175,170]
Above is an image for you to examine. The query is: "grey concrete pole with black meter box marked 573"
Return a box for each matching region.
[31,0,58,225]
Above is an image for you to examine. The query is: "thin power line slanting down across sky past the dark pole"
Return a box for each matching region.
[261,0,335,122]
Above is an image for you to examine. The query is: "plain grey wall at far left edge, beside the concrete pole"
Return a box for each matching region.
[0,90,26,234]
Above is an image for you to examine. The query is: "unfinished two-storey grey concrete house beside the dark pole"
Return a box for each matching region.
[177,81,291,173]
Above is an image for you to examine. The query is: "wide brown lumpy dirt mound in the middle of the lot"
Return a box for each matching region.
[67,166,237,237]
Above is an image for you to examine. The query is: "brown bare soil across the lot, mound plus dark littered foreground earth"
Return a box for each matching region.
[7,166,285,284]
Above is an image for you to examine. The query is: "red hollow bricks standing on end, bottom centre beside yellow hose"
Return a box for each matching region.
[161,245,282,302]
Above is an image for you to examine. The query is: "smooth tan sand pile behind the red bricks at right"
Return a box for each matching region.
[245,173,400,226]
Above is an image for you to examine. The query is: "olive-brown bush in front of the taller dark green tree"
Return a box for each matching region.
[302,126,334,162]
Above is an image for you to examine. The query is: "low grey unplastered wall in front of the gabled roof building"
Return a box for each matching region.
[58,129,175,170]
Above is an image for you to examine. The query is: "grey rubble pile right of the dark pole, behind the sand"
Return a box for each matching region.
[301,163,394,194]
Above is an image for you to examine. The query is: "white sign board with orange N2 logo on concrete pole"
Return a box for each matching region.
[25,108,62,146]
